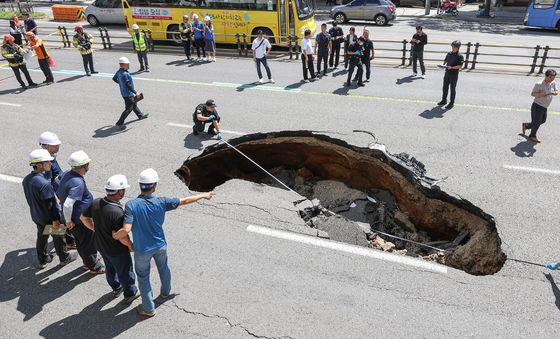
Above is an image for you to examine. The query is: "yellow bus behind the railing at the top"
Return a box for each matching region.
[122,0,316,45]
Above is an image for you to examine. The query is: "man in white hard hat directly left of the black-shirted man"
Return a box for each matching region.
[56,151,105,274]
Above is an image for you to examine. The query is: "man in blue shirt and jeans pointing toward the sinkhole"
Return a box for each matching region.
[113,168,212,317]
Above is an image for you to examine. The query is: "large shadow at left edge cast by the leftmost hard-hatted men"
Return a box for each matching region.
[0,248,94,321]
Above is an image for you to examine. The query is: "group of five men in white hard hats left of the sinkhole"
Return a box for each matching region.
[22,132,212,317]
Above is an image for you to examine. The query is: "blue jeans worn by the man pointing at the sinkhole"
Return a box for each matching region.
[134,246,171,312]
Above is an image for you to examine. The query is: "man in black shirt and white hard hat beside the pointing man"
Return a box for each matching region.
[80,174,140,303]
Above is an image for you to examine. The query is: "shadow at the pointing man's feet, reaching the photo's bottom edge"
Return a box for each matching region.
[39,294,147,339]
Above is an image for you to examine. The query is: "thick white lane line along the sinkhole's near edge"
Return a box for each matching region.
[247,225,447,274]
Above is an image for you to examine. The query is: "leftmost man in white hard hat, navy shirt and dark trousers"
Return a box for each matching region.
[23,149,77,268]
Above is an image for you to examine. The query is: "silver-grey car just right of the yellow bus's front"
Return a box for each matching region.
[331,0,397,26]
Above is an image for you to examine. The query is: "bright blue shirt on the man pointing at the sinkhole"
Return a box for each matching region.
[124,194,179,253]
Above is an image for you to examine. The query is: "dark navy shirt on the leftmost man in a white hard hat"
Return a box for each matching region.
[22,172,54,226]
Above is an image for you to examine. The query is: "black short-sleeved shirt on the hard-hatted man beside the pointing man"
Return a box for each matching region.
[83,198,128,255]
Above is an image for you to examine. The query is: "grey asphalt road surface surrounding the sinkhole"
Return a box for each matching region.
[0,45,560,338]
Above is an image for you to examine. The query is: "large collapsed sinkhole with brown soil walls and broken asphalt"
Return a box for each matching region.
[175,131,506,275]
